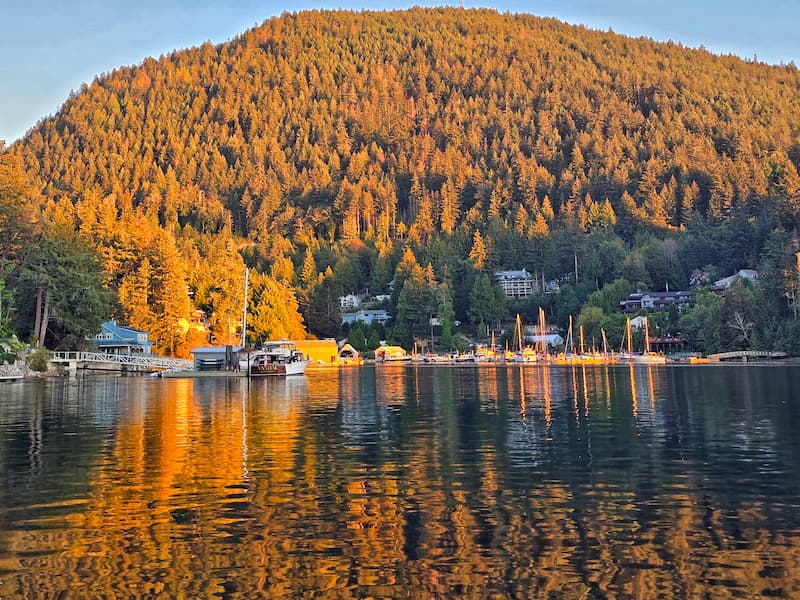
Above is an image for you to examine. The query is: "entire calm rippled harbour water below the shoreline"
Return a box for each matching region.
[0,366,800,598]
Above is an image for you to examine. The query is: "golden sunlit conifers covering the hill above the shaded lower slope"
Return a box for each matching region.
[6,8,800,348]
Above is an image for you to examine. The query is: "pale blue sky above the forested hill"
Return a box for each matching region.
[0,0,800,143]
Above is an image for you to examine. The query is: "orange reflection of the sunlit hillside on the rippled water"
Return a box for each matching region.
[0,366,800,598]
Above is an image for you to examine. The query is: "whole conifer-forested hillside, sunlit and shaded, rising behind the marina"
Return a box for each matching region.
[1,8,800,350]
